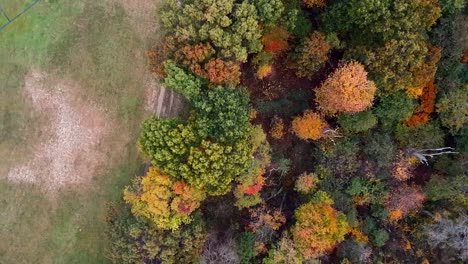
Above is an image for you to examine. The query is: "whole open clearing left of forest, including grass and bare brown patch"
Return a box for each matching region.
[0,0,183,264]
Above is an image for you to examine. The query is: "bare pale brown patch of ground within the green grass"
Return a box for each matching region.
[8,71,112,193]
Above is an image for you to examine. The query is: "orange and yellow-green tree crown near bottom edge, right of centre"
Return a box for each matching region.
[292,202,348,259]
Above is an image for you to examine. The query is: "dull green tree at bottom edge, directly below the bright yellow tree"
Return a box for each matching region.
[106,205,206,264]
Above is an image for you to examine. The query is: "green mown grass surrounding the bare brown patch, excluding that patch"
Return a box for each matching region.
[0,0,158,264]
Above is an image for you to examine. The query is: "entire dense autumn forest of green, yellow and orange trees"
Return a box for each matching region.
[107,0,468,264]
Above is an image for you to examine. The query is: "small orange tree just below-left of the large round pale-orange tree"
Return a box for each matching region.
[292,111,329,140]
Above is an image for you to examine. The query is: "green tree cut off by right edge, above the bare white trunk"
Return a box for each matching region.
[437,85,468,134]
